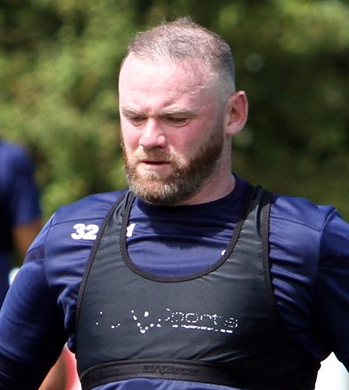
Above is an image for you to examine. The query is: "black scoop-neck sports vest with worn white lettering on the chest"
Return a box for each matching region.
[77,188,319,390]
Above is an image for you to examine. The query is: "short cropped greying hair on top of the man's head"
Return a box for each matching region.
[126,17,235,93]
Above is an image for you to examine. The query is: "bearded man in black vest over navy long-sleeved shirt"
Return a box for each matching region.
[0,19,349,390]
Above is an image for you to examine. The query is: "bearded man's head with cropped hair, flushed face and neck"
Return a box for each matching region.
[119,19,247,205]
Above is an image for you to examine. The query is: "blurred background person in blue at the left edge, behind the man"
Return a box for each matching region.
[0,139,70,390]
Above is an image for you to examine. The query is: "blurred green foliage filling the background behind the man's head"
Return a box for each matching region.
[0,0,349,217]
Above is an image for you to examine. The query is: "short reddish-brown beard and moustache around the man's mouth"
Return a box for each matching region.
[121,131,224,206]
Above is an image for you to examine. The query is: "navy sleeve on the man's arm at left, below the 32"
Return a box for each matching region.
[0,219,66,380]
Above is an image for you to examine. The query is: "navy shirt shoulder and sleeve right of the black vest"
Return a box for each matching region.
[270,197,349,368]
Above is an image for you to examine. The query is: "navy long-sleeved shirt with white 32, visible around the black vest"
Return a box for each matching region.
[0,179,349,390]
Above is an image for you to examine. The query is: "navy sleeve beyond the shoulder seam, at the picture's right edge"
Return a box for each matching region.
[314,211,349,370]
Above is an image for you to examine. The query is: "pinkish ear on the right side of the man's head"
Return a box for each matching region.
[224,91,248,135]
